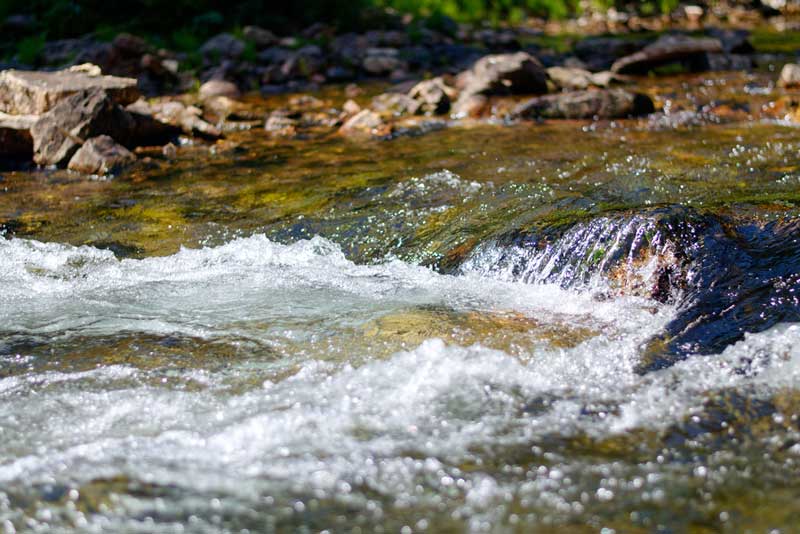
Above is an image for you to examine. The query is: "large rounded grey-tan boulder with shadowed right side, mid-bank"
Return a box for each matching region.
[461,52,547,95]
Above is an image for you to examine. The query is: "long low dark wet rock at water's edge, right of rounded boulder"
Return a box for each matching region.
[513,89,654,119]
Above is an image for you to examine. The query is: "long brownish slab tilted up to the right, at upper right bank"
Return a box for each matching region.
[611,35,723,74]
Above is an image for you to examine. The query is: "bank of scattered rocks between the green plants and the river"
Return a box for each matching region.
[0,6,800,175]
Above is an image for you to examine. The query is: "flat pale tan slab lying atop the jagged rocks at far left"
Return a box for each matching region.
[0,70,140,115]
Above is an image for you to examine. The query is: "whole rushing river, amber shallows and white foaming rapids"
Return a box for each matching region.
[0,71,800,532]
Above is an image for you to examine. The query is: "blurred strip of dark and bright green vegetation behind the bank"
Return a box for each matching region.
[0,0,677,50]
